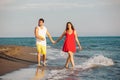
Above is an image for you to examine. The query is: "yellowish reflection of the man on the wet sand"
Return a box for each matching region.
[32,67,45,80]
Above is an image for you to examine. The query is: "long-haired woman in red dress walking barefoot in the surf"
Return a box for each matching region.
[56,22,82,68]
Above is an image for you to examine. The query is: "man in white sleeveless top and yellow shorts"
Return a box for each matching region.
[35,18,55,66]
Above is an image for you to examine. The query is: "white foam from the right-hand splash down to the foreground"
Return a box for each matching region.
[48,55,114,80]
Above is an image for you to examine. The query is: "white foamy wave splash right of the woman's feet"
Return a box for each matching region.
[77,55,114,69]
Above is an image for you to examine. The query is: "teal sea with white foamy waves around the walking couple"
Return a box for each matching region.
[0,37,120,80]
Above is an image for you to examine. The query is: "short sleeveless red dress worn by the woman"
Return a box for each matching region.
[62,31,76,52]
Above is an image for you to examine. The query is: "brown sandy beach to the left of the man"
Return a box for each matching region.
[0,45,37,75]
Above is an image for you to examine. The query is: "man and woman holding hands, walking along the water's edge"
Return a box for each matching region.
[35,18,82,68]
